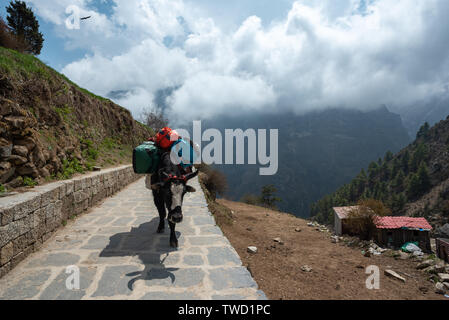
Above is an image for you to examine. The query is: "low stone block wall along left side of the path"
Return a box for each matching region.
[0,166,142,278]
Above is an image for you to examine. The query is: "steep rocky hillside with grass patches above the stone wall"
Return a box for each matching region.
[0,47,152,189]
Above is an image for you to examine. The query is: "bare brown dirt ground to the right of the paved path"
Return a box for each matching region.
[217,200,449,302]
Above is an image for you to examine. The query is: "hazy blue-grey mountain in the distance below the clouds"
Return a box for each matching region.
[194,107,409,217]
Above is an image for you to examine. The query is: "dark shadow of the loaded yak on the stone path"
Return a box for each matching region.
[100,217,180,290]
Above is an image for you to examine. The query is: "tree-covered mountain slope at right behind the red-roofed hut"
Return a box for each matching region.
[311,116,449,227]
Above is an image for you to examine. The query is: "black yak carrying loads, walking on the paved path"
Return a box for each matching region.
[150,152,198,248]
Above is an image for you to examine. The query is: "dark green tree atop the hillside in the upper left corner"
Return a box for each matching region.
[6,0,44,55]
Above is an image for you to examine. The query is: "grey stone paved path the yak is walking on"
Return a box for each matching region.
[0,178,266,300]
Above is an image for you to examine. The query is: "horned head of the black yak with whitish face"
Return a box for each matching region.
[151,169,198,223]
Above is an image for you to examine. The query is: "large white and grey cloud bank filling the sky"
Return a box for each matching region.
[34,0,449,122]
